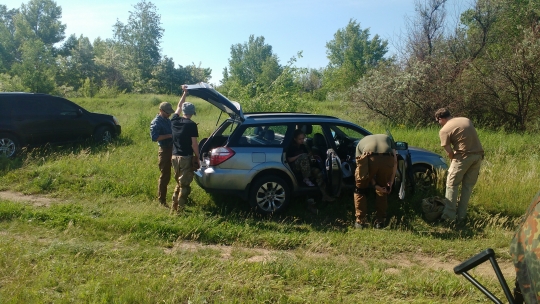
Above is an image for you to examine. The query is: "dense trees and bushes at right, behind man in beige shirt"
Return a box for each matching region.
[350,0,540,131]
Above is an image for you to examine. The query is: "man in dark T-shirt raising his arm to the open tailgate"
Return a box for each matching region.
[171,85,200,213]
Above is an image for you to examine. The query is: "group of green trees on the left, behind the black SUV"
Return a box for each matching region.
[0,0,211,97]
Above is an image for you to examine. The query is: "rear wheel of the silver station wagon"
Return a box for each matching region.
[249,175,291,214]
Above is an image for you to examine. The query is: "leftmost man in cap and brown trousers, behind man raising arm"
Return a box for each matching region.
[150,102,174,208]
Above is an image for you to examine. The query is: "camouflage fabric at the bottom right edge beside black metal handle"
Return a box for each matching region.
[510,192,540,304]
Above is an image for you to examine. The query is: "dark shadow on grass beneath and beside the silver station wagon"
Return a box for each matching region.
[196,182,517,240]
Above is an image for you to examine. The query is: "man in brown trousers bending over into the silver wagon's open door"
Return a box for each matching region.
[354,134,397,229]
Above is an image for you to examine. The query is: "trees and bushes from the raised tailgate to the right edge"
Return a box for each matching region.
[220,0,540,131]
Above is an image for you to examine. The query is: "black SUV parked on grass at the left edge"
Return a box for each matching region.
[0,93,121,157]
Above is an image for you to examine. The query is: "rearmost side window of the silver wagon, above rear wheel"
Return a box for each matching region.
[238,125,287,147]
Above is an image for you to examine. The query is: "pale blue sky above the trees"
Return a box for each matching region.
[2,0,463,84]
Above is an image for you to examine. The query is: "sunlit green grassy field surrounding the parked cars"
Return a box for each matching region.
[0,95,540,303]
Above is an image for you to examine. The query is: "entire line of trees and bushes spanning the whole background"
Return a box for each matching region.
[0,0,540,131]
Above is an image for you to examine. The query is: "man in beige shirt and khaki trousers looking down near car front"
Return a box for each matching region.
[435,108,484,223]
